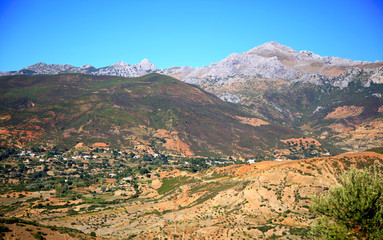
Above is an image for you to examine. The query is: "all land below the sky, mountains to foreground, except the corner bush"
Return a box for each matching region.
[0,42,383,239]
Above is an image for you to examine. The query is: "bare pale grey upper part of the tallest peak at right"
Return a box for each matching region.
[163,42,383,88]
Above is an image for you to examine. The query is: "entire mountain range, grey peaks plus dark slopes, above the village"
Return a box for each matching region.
[0,42,383,158]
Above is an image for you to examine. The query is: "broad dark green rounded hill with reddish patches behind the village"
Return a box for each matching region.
[0,74,304,158]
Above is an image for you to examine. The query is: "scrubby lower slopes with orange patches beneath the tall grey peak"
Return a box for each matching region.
[206,78,383,151]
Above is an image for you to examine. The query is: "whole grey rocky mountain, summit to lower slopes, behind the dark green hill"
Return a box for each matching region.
[2,42,383,153]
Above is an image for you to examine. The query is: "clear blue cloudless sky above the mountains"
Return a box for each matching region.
[0,0,383,71]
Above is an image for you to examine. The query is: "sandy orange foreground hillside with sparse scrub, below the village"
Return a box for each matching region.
[1,152,383,239]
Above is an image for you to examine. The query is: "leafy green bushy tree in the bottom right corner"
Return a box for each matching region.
[311,167,383,239]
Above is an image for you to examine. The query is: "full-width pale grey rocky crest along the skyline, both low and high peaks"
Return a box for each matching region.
[0,42,383,89]
